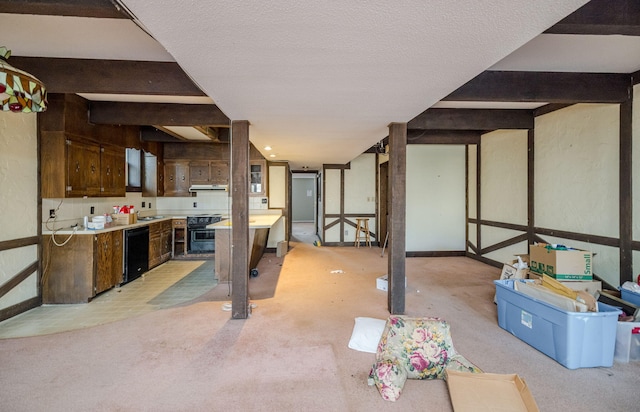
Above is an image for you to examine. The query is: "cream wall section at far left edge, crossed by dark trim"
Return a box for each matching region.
[0,111,38,309]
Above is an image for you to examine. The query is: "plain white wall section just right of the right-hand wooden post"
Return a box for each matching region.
[406,145,465,252]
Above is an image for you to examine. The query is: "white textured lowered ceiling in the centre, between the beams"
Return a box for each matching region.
[123,0,586,168]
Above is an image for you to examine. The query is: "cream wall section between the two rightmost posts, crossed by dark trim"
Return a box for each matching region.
[534,104,620,285]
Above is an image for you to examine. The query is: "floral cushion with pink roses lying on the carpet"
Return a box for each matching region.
[369,315,482,401]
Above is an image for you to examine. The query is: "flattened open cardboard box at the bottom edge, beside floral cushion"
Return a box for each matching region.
[446,370,540,412]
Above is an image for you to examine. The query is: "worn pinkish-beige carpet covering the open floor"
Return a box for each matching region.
[0,243,640,411]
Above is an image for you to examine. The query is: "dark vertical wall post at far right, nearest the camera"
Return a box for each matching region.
[619,98,637,284]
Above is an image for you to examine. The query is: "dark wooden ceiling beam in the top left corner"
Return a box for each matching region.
[0,0,129,19]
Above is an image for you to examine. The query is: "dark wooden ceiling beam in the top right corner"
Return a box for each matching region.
[545,0,640,36]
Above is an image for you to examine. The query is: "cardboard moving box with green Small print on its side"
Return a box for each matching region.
[529,243,593,280]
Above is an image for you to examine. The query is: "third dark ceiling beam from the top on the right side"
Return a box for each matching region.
[407,109,533,130]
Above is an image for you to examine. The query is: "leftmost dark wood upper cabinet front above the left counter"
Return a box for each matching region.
[66,139,100,197]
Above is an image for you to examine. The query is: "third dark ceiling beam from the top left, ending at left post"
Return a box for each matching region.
[89,101,229,126]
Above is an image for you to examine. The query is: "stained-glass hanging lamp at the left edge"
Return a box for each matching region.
[0,46,47,113]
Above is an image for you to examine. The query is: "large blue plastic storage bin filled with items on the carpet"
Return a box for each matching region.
[494,279,622,369]
